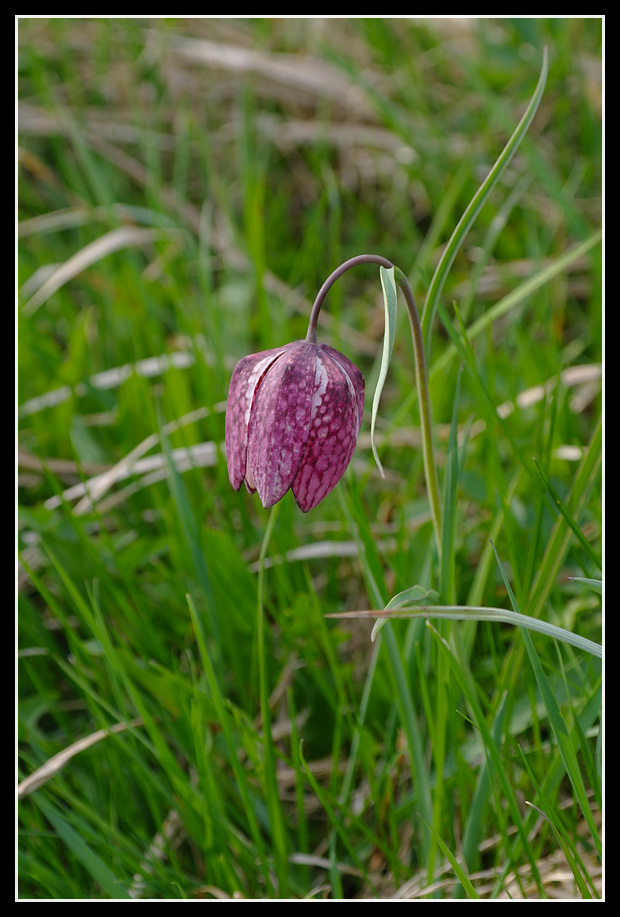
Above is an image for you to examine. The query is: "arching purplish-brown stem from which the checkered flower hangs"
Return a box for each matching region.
[306,254,441,556]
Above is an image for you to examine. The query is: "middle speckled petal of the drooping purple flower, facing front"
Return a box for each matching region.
[247,341,318,507]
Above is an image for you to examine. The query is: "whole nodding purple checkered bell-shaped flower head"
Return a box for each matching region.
[226,341,364,513]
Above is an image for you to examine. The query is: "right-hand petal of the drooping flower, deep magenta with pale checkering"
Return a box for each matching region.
[293,344,364,513]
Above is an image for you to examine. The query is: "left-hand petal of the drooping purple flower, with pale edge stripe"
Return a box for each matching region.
[226,347,286,493]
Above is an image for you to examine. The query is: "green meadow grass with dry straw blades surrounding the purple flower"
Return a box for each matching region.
[16,18,603,900]
